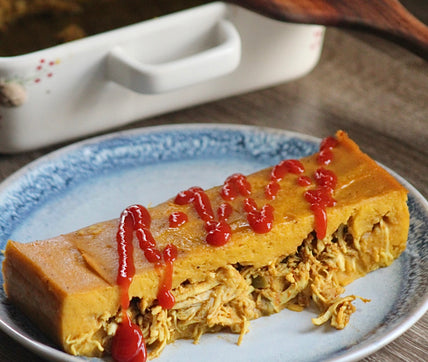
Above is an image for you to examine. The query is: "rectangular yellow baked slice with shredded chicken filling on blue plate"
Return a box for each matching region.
[3,131,409,358]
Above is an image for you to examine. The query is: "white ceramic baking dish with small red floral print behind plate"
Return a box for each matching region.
[0,2,324,152]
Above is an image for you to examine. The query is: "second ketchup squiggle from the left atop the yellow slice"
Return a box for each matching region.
[174,187,232,246]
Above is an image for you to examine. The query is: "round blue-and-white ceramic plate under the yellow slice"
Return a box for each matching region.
[0,125,428,362]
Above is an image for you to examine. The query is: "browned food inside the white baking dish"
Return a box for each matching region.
[0,0,210,56]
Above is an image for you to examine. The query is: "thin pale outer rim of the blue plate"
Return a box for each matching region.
[0,123,428,362]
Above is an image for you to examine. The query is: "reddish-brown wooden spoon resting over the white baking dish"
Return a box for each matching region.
[229,0,428,60]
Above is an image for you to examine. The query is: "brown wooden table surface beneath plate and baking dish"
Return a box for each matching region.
[0,0,428,362]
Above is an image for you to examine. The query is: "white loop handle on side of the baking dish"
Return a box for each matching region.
[107,19,241,94]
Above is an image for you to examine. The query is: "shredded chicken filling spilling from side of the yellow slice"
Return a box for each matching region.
[68,220,390,359]
